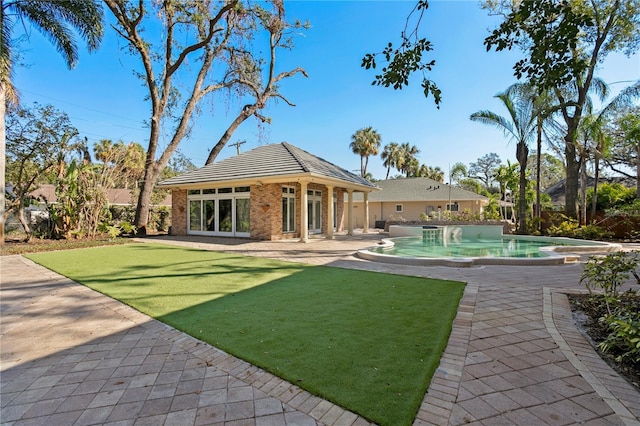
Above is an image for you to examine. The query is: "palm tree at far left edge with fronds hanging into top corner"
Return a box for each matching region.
[0,0,103,245]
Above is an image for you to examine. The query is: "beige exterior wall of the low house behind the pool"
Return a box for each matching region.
[344,200,483,228]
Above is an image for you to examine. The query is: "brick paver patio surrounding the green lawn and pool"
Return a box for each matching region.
[0,233,640,426]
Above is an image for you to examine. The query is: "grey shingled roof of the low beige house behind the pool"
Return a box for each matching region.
[353,178,489,202]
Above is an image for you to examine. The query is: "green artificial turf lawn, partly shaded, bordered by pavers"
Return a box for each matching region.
[27,244,464,425]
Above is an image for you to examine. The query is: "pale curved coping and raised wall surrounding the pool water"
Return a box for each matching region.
[357,225,622,268]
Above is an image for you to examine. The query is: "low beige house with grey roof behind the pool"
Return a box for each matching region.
[353,178,489,227]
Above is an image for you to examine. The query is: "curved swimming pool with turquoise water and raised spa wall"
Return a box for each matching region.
[358,225,621,267]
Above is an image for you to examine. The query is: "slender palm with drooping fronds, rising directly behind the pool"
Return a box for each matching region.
[470,83,538,234]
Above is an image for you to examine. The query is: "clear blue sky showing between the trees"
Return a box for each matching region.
[15,0,640,179]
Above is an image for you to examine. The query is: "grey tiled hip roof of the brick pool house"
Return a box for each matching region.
[159,142,376,191]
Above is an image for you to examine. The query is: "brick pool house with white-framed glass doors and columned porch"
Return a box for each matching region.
[158,142,377,241]
